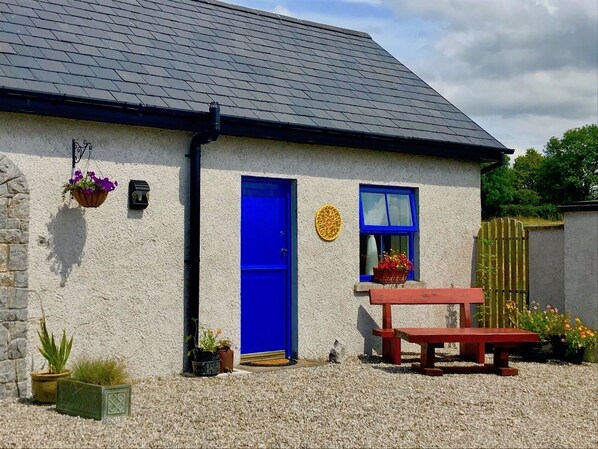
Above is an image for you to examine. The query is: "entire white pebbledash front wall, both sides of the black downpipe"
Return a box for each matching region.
[0,113,480,377]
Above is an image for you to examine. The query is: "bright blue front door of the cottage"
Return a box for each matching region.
[241,178,291,358]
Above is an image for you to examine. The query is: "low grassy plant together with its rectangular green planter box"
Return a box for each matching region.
[56,358,131,420]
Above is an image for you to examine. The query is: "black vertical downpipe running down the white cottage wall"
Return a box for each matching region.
[183,102,220,371]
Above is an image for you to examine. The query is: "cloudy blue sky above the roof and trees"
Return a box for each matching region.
[228,0,598,155]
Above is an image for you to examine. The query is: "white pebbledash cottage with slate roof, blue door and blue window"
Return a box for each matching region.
[0,0,512,397]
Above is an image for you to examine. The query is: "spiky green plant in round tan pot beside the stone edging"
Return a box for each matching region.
[31,316,73,403]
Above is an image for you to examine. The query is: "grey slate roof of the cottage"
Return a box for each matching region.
[0,0,512,153]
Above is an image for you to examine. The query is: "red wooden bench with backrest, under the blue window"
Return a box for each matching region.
[370,288,484,365]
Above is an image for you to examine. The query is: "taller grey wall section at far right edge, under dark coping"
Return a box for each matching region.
[564,211,598,329]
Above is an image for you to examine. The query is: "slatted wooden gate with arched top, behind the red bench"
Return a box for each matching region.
[476,218,528,327]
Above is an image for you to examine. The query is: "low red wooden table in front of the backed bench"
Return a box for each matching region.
[395,327,540,376]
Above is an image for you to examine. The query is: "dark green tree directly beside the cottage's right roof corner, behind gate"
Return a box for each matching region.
[481,156,515,219]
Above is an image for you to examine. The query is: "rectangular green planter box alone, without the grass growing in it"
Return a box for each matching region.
[56,379,131,420]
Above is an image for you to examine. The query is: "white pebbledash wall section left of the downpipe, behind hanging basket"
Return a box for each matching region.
[0,113,191,377]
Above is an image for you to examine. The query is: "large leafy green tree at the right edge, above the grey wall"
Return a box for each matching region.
[538,124,598,204]
